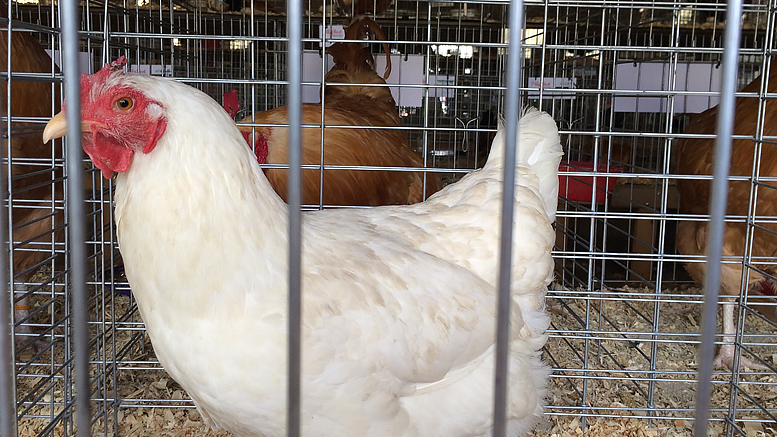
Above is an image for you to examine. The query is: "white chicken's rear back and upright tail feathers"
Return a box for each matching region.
[316,109,562,331]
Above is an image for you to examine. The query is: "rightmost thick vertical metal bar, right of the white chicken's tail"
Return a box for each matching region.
[694,0,742,437]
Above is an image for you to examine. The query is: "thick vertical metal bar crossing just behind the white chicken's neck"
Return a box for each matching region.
[286,0,303,437]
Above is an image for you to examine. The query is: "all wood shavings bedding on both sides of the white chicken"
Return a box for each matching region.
[12,282,777,437]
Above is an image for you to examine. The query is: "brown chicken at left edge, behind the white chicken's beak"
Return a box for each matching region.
[0,5,64,349]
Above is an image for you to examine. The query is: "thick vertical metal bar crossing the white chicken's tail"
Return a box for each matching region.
[493,0,523,436]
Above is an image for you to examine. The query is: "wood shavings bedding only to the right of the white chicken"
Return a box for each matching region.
[533,287,777,436]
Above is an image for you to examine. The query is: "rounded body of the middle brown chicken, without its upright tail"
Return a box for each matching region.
[245,104,437,206]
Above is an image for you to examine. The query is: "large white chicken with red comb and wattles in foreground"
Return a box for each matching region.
[44,59,561,437]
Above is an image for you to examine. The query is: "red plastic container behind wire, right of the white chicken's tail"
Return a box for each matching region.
[558,161,622,203]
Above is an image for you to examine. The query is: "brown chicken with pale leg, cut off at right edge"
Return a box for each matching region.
[676,62,777,368]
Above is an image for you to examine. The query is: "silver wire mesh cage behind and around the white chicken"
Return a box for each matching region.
[0,0,777,436]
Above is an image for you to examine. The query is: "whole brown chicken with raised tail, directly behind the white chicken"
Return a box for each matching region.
[228,18,437,206]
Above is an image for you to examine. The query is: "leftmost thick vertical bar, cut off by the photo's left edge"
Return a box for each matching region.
[0,2,16,436]
